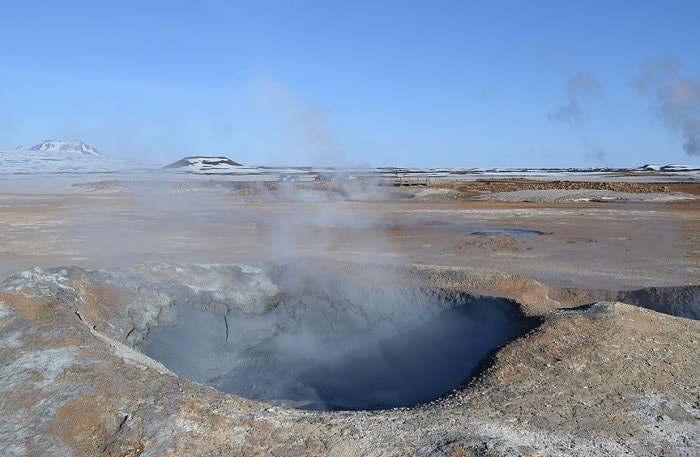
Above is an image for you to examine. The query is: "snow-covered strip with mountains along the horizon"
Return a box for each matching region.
[0,140,700,182]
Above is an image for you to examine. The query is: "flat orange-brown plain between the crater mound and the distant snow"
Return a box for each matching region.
[0,179,700,289]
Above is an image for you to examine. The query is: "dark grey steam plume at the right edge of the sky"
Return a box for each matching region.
[632,57,700,155]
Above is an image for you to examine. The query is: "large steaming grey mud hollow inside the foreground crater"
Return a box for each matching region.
[134,260,536,410]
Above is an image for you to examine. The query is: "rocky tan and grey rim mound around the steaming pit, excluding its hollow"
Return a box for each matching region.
[0,264,700,456]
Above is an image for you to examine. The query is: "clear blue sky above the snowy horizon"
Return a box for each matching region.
[0,0,700,167]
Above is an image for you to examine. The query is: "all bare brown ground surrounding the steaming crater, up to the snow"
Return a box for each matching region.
[0,176,700,456]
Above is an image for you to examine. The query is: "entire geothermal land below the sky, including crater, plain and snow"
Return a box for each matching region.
[0,151,700,456]
